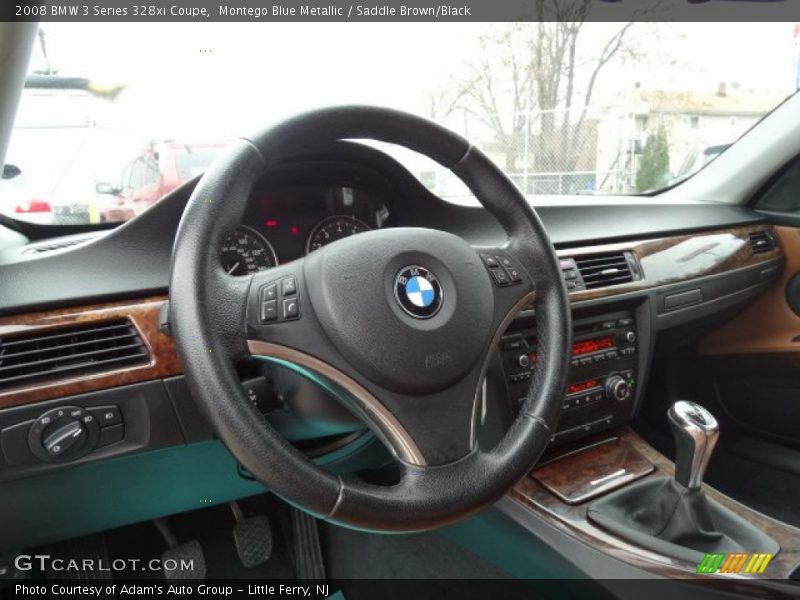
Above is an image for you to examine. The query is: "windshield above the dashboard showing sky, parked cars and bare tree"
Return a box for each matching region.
[0,22,798,223]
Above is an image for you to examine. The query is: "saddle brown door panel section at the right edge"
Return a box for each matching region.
[698,227,800,356]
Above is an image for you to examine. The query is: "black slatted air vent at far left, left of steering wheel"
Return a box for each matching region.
[0,319,148,389]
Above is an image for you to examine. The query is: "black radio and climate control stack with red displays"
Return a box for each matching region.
[499,311,639,444]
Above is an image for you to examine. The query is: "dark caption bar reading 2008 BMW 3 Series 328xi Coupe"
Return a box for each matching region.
[0,0,800,23]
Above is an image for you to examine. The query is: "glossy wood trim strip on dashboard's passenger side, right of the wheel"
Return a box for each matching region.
[558,224,783,302]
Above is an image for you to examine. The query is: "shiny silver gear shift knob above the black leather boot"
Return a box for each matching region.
[667,400,719,489]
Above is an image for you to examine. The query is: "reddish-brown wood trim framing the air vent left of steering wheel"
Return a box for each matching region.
[0,296,182,408]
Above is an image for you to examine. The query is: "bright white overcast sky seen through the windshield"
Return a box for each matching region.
[29,23,795,140]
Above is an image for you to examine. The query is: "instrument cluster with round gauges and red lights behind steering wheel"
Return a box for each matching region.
[220,182,390,276]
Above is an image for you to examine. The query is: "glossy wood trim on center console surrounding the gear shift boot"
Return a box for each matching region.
[511,427,800,580]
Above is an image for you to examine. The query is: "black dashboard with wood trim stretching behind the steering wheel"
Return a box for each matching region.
[0,143,784,550]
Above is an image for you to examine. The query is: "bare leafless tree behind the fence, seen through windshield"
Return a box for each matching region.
[439,5,636,178]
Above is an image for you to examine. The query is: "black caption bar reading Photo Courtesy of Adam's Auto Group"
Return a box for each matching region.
[0,577,798,600]
